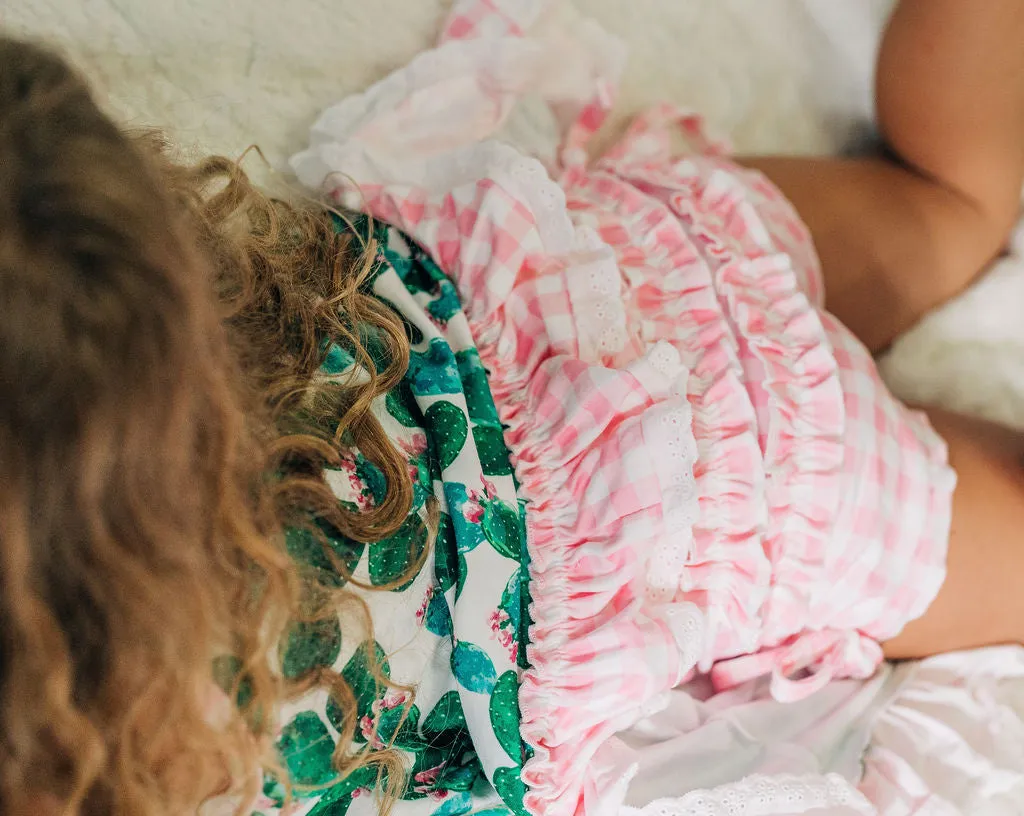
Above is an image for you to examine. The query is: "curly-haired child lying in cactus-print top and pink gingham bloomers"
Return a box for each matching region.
[6,0,1024,816]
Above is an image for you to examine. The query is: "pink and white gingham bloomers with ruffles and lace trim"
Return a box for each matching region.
[294,0,954,816]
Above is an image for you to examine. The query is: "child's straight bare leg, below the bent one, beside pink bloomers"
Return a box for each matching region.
[885,411,1024,658]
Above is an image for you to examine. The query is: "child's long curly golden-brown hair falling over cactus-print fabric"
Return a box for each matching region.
[0,37,426,816]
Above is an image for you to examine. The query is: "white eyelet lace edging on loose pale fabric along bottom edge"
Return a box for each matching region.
[620,774,874,816]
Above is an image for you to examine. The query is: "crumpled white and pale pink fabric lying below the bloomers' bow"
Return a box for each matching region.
[606,647,1024,816]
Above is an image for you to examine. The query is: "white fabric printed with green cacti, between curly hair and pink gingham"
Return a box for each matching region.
[257,226,528,816]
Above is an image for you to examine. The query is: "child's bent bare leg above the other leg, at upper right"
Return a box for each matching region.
[742,0,1024,350]
